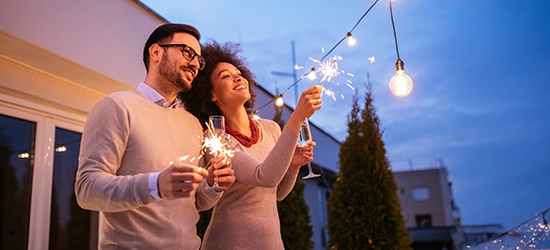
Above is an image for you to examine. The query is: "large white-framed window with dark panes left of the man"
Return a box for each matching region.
[0,101,95,249]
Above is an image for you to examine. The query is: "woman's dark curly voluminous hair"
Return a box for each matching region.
[178,41,257,128]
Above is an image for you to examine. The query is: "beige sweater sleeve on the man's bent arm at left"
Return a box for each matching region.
[75,97,153,212]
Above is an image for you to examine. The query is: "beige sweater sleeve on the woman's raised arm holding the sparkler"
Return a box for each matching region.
[232,123,298,187]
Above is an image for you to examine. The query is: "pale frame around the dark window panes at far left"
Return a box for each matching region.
[0,93,92,249]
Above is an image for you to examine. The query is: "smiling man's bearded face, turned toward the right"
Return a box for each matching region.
[159,33,201,92]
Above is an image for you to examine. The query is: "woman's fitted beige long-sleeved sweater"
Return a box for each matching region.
[201,120,298,250]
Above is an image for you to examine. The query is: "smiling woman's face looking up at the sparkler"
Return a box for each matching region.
[210,62,250,110]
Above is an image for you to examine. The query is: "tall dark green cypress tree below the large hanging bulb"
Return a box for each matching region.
[327,85,412,250]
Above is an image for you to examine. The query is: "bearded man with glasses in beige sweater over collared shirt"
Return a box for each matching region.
[75,24,235,249]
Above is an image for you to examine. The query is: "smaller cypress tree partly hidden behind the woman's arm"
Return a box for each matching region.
[273,102,313,250]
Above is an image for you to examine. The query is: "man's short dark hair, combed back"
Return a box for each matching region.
[143,23,201,71]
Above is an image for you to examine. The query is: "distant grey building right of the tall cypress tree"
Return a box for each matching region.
[394,167,462,250]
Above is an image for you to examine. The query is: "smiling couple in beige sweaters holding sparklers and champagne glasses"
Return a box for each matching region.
[75,24,321,249]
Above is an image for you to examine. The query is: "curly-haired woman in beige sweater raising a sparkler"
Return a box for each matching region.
[180,42,321,250]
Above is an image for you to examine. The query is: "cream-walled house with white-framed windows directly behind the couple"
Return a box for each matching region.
[0,0,339,249]
